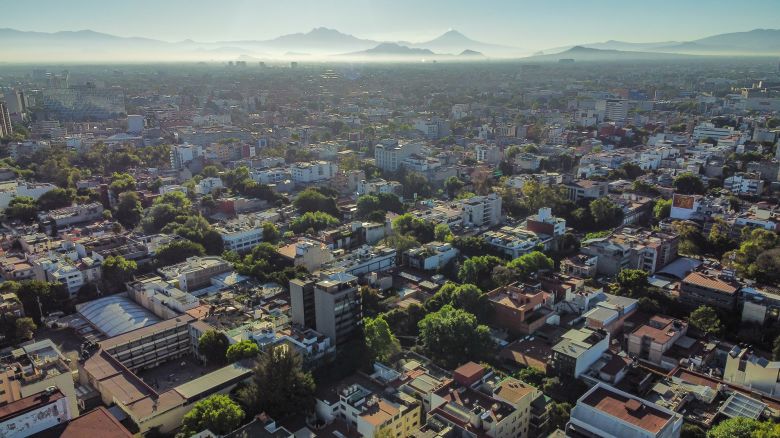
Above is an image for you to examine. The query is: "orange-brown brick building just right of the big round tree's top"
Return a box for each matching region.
[487,283,555,336]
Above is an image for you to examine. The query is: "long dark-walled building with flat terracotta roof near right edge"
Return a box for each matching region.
[679,272,739,312]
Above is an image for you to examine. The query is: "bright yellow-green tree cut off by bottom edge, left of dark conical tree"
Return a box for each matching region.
[180,394,244,437]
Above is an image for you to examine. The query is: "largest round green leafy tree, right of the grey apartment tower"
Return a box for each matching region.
[418,304,493,368]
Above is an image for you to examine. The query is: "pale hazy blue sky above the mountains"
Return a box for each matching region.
[0,0,780,49]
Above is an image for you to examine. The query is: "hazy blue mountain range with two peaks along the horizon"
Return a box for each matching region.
[0,27,780,62]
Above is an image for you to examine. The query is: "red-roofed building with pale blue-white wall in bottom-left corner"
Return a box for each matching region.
[0,388,73,438]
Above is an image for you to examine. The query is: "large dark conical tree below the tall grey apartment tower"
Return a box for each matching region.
[237,347,315,420]
